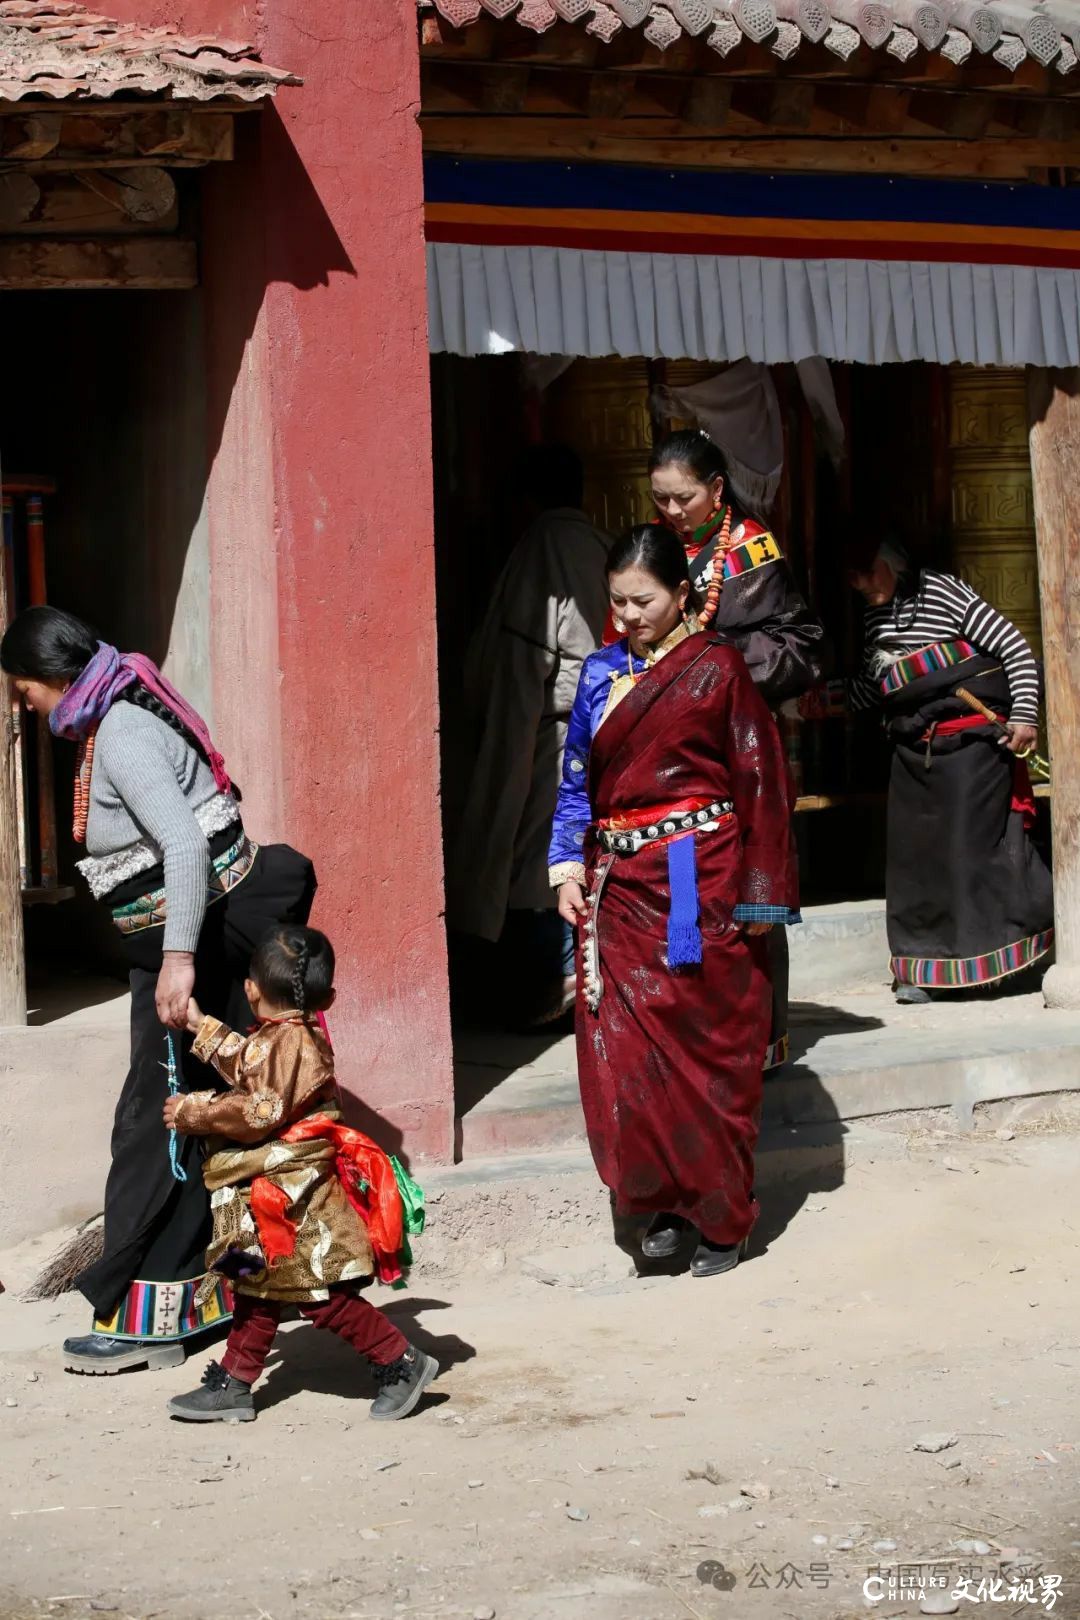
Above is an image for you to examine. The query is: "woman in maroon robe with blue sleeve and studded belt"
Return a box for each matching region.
[551,525,798,1277]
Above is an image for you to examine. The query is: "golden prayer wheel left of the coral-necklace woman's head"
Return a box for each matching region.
[549,360,654,535]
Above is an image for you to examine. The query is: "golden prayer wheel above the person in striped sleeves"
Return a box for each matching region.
[949,366,1043,656]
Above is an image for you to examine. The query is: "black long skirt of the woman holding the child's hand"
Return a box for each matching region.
[76,844,316,1338]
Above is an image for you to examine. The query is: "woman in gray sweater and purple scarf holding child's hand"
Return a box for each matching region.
[0,608,316,1372]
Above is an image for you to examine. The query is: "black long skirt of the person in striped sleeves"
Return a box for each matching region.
[886,726,1054,990]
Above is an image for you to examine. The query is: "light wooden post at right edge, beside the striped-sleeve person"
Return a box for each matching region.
[1028,366,1080,1011]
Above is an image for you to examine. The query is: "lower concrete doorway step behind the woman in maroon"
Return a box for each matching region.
[458,988,1080,1163]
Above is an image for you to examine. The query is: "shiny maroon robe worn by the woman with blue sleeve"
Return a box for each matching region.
[578,633,798,1244]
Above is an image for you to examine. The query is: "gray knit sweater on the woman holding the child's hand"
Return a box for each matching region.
[79,701,240,951]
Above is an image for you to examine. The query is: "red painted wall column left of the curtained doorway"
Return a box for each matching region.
[108,0,453,1157]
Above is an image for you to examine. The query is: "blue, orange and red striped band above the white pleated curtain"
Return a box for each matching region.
[424,154,1080,269]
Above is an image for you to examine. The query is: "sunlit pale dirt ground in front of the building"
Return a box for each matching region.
[0,1123,1080,1620]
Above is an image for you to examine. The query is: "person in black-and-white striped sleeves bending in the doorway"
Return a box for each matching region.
[848,541,1054,1003]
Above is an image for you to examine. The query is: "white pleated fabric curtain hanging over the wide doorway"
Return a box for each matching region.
[427,243,1080,366]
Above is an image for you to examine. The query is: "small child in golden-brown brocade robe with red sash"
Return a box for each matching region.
[165,927,439,1422]
